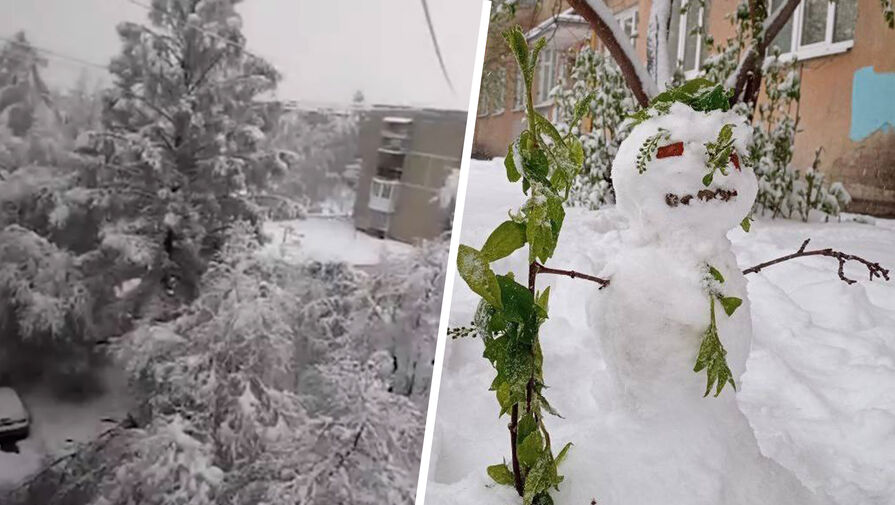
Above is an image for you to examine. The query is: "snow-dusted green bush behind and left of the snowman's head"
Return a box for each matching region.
[552,46,636,209]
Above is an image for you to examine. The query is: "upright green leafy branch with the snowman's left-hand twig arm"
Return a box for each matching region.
[450,27,596,505]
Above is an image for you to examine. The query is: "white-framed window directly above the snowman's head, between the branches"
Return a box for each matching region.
[668,0,709,78]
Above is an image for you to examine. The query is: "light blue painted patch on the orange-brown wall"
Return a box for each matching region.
[848,67,895,142]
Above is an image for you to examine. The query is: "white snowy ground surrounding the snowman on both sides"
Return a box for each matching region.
[427,160,895,505]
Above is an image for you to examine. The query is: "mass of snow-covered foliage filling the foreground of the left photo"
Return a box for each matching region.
[7,223,428,505]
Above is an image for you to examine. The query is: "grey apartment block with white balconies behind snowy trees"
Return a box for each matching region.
[354,107,466,242]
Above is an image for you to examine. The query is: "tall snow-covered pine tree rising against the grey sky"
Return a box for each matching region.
[83,0,288,299]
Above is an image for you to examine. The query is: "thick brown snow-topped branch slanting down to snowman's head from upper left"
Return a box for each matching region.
[569,0,658,107]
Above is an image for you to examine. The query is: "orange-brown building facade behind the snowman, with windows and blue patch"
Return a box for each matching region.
[474,0,895,217]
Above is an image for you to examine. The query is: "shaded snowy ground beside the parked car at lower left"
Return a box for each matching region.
[0,369,129,492]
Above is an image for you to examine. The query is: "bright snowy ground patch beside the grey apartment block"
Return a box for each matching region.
[262,217,413,266]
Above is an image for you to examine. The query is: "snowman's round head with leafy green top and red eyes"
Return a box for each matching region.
[612,79,758,234]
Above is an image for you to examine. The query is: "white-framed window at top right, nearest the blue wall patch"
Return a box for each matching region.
[769,0,858,59]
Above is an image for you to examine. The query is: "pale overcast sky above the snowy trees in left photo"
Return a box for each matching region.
[0,0,482,110]
